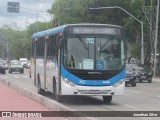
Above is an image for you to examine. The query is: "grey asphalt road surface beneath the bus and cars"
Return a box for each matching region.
[0,70,160,120]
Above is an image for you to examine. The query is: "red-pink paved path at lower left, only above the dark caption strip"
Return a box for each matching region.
[0,83,49,111]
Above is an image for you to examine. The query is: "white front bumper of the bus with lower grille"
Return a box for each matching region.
[61,80,125,96]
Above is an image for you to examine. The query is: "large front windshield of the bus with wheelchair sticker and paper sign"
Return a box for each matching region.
[64,35,125,70]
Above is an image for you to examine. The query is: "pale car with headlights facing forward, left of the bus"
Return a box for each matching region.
[9,60,24,73]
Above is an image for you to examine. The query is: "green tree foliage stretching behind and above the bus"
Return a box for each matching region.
[0,0,159,62]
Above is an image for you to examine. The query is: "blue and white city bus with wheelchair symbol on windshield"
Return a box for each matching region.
[30,24,126,103]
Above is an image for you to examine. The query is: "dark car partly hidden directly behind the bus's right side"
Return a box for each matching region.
[125,64,136,87]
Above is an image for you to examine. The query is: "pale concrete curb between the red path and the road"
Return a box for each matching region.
[0,79,96,120]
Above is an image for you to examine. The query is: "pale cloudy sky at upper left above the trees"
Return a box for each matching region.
[0,0,53,29]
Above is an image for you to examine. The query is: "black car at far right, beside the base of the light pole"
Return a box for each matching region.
[131,64,153,83]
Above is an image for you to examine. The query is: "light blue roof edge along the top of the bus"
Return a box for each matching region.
[32,23,122,39]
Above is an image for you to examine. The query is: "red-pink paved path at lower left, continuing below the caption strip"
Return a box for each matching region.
[0,83,66,120]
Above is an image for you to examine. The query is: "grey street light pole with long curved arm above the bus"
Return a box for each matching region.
[89,6,144,64]
